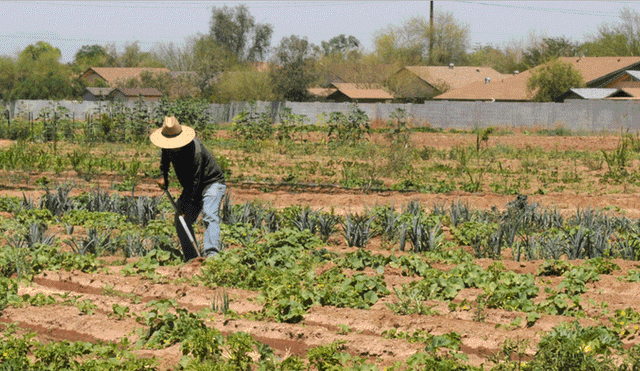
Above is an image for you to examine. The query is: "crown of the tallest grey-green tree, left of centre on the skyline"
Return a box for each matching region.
[209,5,273,61]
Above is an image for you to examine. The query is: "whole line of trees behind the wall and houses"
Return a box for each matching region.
[0,5,640,103]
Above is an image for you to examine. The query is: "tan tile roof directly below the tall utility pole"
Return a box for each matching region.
[405,66,505,89]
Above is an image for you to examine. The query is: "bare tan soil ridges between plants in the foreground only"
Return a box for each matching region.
[0,250,640,369]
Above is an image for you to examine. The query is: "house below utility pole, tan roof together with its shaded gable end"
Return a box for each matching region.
[387,64,505,101]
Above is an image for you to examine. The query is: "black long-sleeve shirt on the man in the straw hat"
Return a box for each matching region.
[160,138,224,201]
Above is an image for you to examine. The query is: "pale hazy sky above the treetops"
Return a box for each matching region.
[0,1,640,63]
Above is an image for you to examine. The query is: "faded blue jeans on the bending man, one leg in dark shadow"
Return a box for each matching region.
[175,183,227,261]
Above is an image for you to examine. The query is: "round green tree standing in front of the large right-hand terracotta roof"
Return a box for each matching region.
[527,59,585,102]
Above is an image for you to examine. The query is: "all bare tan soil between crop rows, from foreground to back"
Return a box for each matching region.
[0,134,640,370]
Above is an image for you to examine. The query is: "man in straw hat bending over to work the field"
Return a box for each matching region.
[149,117,227,261]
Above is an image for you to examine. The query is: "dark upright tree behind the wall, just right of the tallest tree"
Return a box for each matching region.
[270,35,315,102]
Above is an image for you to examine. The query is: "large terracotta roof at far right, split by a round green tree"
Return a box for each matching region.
[433,57,640,102]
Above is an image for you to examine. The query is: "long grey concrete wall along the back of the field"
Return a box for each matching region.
[5,100,640,132]
